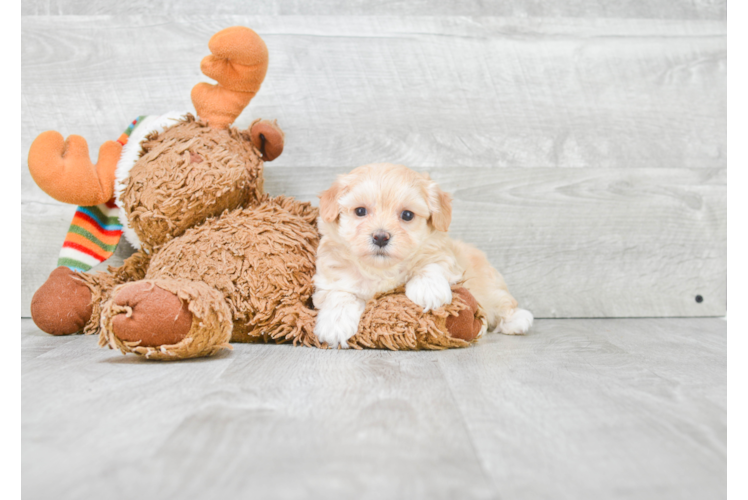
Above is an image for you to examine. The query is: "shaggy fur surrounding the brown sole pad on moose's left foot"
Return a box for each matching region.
[99,279,232,361]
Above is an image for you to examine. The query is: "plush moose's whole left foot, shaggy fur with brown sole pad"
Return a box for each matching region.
[99,279,233,360]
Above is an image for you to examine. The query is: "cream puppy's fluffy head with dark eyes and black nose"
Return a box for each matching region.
[320,164,452,267]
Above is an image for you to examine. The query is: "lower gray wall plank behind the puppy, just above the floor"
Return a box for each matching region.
[21,165,726,318]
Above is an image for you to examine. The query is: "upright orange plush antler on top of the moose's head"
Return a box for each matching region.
[192,26,268,129]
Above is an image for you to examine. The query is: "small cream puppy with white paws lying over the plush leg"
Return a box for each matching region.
[313,164,533,347]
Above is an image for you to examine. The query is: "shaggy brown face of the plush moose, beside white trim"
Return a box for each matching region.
[121,116,263,248]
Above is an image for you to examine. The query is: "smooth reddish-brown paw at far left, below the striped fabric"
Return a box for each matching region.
[31,267,93,335]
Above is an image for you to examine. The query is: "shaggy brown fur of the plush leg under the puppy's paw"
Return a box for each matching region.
[348,287,485,351]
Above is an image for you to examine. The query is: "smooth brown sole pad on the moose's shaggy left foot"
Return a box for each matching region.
[112,282,192,347]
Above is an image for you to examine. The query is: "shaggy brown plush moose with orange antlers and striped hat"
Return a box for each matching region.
[29,27,485,360]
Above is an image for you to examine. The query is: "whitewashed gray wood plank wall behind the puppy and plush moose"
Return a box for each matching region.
[21,0,735,317]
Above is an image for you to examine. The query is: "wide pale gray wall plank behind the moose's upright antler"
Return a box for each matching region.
[21,17,726,168]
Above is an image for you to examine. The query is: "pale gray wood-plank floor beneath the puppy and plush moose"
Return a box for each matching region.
[21,319,735,500]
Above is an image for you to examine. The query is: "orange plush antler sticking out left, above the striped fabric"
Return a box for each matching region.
[29,132,122,207]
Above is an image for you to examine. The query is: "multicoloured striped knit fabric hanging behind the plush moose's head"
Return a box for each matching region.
[57,116,146,272]
